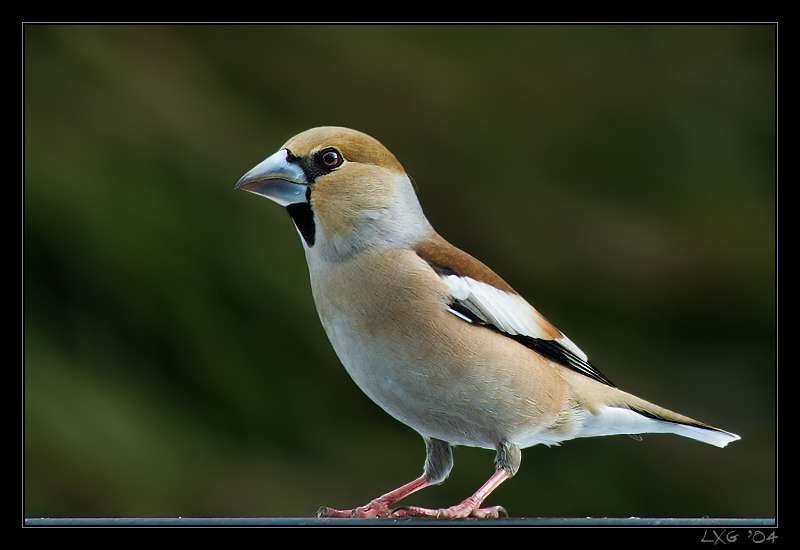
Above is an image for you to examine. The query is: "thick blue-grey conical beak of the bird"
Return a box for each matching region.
[235,149,308,206]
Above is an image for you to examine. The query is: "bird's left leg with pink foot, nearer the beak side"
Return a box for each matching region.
[317,439,453,518]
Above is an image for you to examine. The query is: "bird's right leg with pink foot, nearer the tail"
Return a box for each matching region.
[392,441,522,518]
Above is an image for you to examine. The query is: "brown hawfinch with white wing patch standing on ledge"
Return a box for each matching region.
[235,126,740,518]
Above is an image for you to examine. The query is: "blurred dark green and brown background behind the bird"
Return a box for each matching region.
[22,25,777,517]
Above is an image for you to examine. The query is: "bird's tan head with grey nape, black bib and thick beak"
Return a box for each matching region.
[236,126,432,260]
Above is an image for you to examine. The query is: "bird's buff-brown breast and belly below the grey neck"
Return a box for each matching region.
[309,249,567,448]
